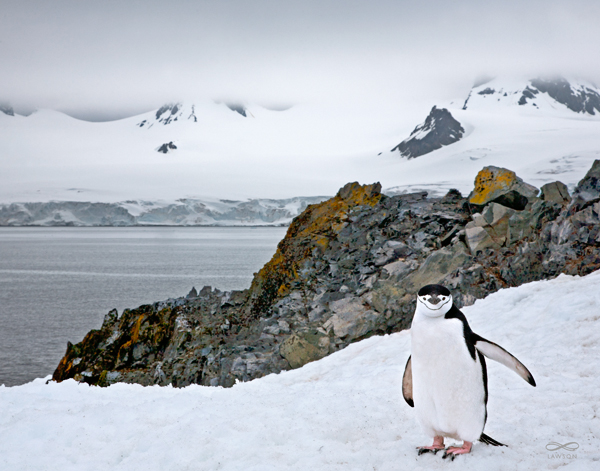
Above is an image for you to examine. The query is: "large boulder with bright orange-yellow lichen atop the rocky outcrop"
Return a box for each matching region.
[469,166,539,211]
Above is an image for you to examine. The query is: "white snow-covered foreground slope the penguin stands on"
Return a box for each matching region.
[0,272,600,471]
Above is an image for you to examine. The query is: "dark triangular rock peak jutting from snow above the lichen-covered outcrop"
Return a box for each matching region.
[392,106,465,159]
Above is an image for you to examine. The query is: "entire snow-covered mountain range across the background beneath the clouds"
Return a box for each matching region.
[0,78,600,224]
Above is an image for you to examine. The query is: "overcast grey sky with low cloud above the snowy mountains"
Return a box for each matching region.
[0,0,600,120]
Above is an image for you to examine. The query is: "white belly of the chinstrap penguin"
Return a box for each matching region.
[411,316,486,442]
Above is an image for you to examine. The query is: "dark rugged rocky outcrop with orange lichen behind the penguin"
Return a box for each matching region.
[54,161,600,386]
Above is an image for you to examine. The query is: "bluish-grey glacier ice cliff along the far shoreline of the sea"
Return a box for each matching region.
[0,196,328,226]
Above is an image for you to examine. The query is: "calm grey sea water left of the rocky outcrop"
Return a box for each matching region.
[0,227,286,386]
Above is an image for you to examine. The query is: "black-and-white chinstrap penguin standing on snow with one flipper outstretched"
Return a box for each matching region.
[402,285,535,460]
